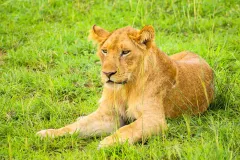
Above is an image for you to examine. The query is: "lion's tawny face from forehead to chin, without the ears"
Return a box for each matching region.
[98,32,142,85]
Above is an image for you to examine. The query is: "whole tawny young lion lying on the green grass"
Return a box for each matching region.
[37,25,214,148]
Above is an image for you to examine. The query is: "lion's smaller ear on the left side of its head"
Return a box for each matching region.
[89,25,110,43]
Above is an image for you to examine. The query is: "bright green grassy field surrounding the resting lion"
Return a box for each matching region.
[0,0,240,160]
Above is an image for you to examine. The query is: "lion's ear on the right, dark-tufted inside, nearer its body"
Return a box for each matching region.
[131,26,154,48]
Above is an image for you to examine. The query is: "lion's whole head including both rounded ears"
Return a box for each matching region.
[90,25,154,87]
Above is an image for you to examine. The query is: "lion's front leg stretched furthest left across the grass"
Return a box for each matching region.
[37,110,121,137]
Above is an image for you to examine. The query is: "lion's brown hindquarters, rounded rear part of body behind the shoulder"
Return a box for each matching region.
[165,51,213,117]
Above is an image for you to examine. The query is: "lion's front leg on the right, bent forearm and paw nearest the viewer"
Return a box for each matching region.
[99,114,167,148]
